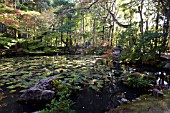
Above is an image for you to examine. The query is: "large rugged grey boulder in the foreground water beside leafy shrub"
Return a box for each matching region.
[18,77,57,104]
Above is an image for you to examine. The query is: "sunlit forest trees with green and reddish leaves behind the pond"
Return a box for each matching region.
[0,0,170,59]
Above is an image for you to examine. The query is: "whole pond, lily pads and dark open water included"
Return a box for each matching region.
[0,55,167,113]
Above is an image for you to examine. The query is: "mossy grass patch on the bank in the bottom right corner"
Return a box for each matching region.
[108,90,170,113]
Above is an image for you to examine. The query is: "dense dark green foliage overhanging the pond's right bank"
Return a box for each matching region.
[118,28,167,62]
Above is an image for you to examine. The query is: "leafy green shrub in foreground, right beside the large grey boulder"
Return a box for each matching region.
[40,80,75,113]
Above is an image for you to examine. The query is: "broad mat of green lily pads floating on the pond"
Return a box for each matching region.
[0,56,113,93]
